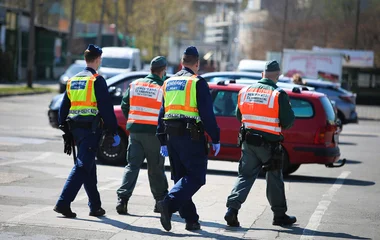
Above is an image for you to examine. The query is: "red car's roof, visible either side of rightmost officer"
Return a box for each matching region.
[208,83,325,98]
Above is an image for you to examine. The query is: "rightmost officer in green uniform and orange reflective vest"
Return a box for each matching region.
[224,61,296,227]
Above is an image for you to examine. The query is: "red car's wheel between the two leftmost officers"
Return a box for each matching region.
[97,129,128,165]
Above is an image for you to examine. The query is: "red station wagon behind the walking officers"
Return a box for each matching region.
[209,81,340,175]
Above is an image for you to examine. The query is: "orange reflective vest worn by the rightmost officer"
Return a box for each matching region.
[238,85,281,135]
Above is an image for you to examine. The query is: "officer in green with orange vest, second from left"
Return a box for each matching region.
[116,56,168,214]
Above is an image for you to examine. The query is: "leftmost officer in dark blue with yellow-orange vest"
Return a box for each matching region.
[54,44,120,218]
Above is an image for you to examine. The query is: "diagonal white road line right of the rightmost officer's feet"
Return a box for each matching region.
[300,171,351,240]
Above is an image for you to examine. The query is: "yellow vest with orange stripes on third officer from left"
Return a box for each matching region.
[163,75,200,121]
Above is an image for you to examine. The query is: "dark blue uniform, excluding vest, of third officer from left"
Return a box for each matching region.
[157,67,220,223]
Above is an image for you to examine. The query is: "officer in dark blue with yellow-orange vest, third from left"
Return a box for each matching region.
[157,46,220,231]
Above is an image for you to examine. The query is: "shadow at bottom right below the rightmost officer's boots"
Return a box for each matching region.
[251,226,371,239]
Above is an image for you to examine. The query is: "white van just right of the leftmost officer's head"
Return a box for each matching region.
[99,47,142,78]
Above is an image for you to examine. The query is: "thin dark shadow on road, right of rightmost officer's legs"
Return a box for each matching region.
[284,175,375,186]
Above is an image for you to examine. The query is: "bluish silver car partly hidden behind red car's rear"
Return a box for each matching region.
[303,79,358,124]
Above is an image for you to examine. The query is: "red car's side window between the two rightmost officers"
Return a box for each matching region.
[214,91,239,117]
